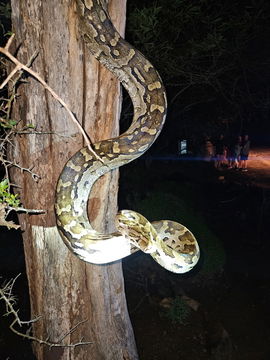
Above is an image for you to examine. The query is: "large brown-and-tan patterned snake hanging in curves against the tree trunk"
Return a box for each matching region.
[55,0,199,273]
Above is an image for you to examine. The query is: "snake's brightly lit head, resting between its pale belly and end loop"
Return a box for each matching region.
[116,210,157,254]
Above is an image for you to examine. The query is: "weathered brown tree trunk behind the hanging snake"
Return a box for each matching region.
[10,0,138,360]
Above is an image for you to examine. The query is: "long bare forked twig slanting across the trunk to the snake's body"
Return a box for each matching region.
[0,34,103,163]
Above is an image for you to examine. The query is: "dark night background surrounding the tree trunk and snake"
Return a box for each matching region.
[0,0,270,360]
